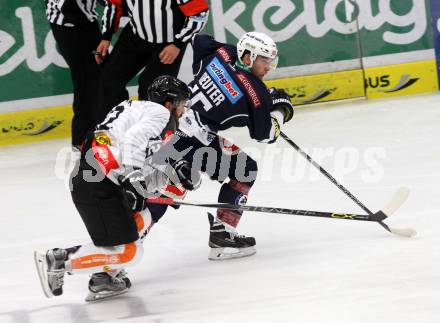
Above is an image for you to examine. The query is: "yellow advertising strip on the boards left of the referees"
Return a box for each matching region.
[0,105,72,146]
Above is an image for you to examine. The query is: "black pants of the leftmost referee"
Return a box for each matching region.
[51,21,101,146]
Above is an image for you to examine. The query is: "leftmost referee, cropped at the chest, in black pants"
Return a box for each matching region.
[45,0,101,150]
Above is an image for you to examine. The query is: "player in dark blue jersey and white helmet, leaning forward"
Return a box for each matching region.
[156,32,293,260]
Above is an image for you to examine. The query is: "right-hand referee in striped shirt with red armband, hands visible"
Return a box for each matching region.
[95,0,208,125]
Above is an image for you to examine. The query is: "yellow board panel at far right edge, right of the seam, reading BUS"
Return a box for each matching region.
[365,61,438,99]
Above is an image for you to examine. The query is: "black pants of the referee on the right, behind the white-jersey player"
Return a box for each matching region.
[99,25,186,122]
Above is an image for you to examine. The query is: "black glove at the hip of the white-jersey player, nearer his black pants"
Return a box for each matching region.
[118,169,147,212]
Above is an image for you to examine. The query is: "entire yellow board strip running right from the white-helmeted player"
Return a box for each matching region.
[266,60,438,105]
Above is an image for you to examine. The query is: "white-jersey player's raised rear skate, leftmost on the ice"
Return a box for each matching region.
[34,248,67,298]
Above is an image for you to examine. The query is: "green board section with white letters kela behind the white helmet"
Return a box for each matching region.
[209,0,360,67]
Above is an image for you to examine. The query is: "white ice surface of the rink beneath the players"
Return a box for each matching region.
[0,95,440,323]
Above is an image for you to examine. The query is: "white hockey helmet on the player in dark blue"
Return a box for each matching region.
[237,31,278,69]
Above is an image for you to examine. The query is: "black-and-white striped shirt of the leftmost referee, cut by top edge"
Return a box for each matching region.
[45,0,98,27]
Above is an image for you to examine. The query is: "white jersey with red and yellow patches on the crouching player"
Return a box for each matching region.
[92,100,174,192]
